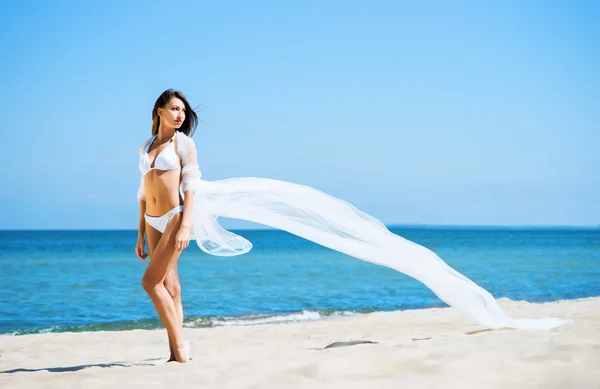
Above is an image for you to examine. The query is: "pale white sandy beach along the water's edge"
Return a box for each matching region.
[0,298,600,389]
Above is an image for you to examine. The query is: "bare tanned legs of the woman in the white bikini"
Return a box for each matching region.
[142,214,187,362]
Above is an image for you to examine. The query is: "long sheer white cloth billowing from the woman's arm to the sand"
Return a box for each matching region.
[138,133,570,329]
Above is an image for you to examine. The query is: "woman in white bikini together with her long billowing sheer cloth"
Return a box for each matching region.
[136,90,568,362]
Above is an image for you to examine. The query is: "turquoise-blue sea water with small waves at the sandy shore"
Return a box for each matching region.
[0,227,600,334]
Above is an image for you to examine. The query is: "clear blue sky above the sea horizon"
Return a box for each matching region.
[0,1,600,229]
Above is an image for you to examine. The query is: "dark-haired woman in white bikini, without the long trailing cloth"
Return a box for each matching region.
[135,90,199,362]
